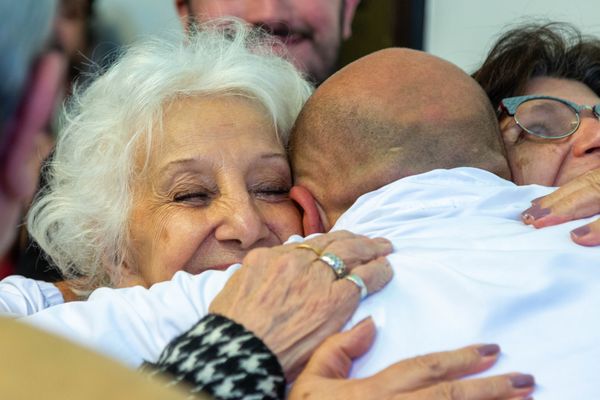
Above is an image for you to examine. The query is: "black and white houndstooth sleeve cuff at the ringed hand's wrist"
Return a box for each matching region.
[144,314,285,399]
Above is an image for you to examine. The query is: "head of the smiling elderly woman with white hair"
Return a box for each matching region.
[28,20,312,290]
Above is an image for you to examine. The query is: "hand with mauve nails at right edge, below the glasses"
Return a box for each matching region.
[522,169,600,246]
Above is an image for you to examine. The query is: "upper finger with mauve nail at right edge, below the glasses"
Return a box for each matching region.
[522,186,600,228]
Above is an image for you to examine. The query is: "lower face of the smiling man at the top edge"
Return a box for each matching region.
[179,0,354,82]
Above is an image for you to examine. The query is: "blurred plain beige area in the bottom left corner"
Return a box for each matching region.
[0,318,209,400]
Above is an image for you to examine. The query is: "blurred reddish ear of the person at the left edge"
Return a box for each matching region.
[2,52,66,198]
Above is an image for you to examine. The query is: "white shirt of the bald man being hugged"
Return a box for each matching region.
[19,168,600,399]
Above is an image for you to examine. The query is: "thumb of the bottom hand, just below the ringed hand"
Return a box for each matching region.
[303,317,375,379]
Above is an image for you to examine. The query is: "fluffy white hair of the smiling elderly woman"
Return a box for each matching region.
[28,18,313,290]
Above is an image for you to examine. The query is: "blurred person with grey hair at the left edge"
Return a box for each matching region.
[0,1,66,276]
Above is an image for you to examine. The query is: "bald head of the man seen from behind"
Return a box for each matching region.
[290,49,509,227]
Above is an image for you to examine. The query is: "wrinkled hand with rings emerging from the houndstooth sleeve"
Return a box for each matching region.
[209,231,392,381]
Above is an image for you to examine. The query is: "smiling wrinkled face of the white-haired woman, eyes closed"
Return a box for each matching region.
[122,96,301,286]
